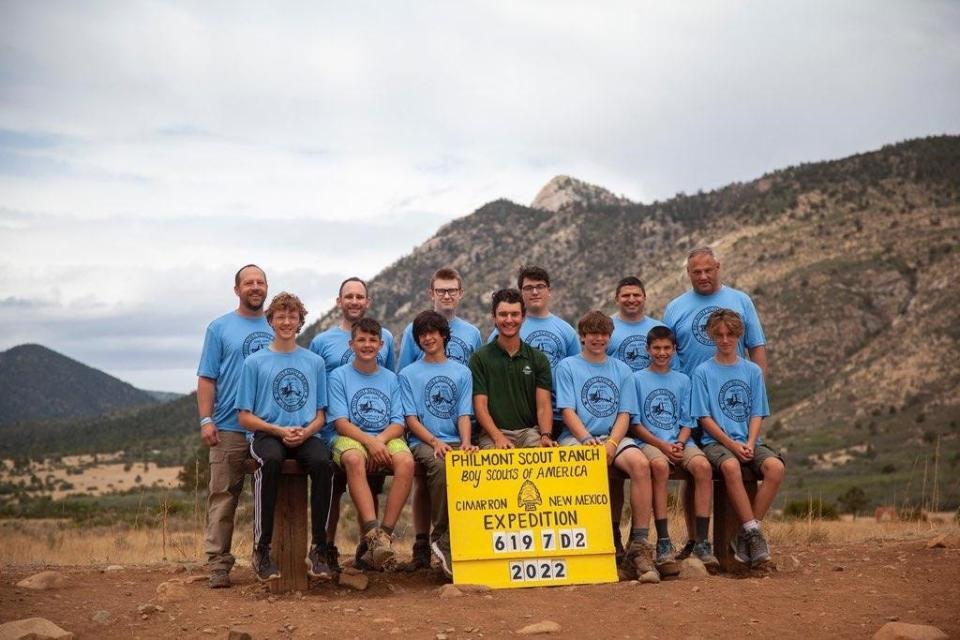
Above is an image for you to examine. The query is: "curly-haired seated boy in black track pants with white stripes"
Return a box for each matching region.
[237,292,333,581]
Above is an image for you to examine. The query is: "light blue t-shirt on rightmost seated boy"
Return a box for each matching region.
[690,358,770,445]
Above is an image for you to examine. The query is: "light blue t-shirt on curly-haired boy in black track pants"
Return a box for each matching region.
[237,347,327,438]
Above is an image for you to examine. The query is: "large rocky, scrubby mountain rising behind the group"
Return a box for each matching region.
[302,136,960,505]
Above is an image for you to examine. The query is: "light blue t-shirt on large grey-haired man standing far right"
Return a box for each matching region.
[663,285,766,377]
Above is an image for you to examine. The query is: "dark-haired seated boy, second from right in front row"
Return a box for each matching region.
[633,326,720,575]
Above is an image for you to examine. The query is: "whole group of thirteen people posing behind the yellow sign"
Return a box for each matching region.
[197,247,784,588]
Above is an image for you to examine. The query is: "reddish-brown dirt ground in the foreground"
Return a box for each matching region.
[0,541,960,640]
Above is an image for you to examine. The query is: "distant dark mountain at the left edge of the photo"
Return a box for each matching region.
[0,344,157,423]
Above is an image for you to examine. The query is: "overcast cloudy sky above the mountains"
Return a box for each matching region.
[0,0,960,391]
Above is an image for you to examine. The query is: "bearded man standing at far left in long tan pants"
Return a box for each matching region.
[197,264,273,589]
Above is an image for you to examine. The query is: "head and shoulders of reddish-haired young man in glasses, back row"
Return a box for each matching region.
[397,267,481,372]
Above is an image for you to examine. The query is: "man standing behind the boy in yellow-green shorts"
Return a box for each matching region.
[310,276,394,571]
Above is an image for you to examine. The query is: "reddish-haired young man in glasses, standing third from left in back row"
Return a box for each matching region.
[397,267,481,571]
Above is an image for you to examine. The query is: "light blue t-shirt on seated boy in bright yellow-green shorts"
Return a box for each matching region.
[324,364,403,441]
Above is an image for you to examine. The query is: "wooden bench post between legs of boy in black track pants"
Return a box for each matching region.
[270,460,310,593]
